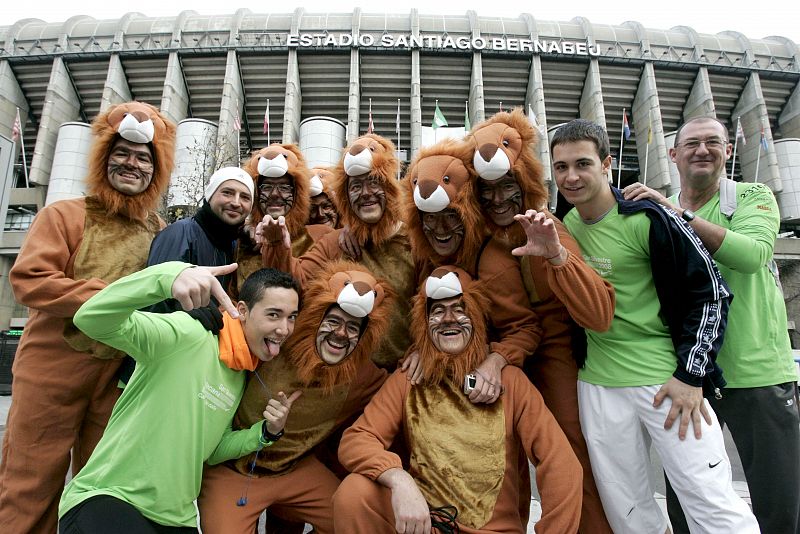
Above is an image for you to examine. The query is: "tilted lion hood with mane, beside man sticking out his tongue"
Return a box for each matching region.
[286,261,395,390]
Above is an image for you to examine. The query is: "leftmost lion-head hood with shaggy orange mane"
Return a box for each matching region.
[86,102,175,220]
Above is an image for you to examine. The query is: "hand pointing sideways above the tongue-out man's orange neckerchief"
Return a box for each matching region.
[172,263,239,318]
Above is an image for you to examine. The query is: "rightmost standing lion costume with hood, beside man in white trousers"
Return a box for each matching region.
[467,109,615,534]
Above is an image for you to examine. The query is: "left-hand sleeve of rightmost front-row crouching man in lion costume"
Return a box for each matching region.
[339,370,411,480]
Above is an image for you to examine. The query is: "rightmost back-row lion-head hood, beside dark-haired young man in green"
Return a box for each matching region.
[465,108,548,241]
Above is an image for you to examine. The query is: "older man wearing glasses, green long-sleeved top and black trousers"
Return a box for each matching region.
[624,117,800,533]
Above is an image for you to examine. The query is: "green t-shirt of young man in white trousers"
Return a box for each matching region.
[564,204,677,387]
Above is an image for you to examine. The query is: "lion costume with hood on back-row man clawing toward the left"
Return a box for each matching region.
[262,134,416,370]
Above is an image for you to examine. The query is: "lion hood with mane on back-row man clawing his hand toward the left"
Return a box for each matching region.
[333,134,402,246]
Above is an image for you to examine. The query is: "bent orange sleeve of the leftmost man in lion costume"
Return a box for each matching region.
[9,200,107,318]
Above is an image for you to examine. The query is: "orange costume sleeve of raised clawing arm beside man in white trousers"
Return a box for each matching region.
[542,220,616,332]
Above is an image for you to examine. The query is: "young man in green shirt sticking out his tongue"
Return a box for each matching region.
[59,262,299,534]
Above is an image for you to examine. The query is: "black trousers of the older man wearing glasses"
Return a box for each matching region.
[665,382,800,534]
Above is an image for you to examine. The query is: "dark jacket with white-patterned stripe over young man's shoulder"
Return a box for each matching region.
[611,187,733,394]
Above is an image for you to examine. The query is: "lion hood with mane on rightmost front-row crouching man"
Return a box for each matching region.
[410,265,489,384]
